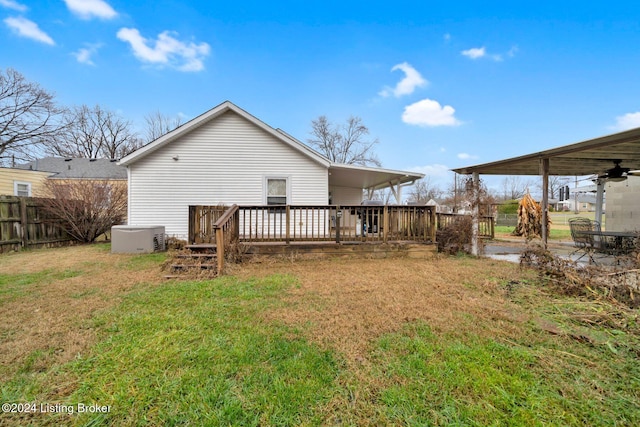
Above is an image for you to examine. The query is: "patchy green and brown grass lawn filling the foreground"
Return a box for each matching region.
[0,248,640,426]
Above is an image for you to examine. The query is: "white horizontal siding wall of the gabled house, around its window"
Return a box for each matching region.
[129,112,328,239]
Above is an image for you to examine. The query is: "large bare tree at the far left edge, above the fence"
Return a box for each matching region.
[0,68,63,162]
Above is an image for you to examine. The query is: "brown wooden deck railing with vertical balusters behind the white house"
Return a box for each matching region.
[189,205,436,244]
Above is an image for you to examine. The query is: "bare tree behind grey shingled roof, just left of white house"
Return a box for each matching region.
[46,105,141,159]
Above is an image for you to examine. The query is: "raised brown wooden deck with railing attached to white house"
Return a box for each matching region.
[188,205,493,272]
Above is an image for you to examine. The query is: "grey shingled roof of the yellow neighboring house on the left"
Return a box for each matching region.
[16,157,127,179]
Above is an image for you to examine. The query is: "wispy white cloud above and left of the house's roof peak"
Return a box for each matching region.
[117,28,210,71]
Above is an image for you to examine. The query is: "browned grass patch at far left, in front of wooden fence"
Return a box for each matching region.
[0,245,161,374]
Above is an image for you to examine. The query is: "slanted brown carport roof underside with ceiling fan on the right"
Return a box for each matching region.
[453,128,640,176]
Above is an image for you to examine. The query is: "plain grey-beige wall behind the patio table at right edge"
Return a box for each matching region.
[605,176,640,231]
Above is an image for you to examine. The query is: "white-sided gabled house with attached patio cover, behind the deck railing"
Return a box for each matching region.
[119,101,424,238]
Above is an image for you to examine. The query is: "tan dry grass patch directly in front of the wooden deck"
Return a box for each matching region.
[239,257,530,363]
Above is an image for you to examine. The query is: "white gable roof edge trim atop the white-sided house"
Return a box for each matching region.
[118,101,331,167]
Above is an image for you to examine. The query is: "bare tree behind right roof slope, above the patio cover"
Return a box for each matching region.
[307,116,381,166]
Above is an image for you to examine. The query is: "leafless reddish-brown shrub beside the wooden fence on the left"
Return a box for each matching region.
[42,179,127,243]
